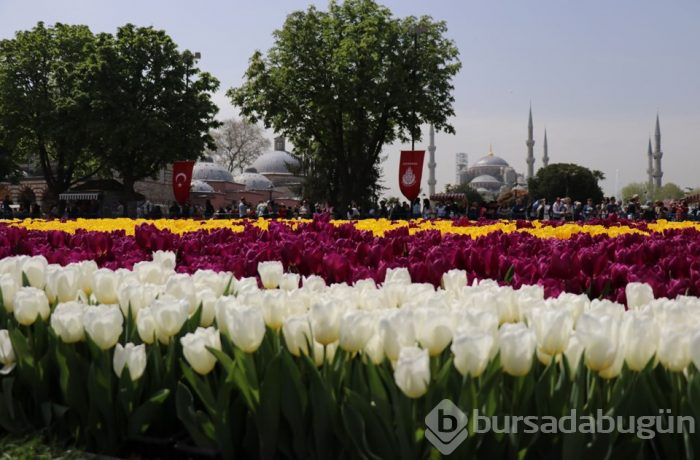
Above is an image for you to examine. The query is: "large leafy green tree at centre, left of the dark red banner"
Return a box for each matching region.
[228,0,461,205]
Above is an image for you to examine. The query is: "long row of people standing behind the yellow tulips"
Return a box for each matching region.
[1,195,700,221]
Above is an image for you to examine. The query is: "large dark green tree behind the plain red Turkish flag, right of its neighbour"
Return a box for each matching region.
[90,24,219,214]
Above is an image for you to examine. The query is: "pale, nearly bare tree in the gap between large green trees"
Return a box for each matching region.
[211,119,270,172]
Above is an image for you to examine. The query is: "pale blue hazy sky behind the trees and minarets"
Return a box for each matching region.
[0,0,700,196]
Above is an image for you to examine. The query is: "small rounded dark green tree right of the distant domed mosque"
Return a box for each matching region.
[528,163,604,203]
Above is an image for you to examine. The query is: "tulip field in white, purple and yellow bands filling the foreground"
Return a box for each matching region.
[0,219,700,459]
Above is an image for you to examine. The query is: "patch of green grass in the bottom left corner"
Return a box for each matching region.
[0,434,86,460]
